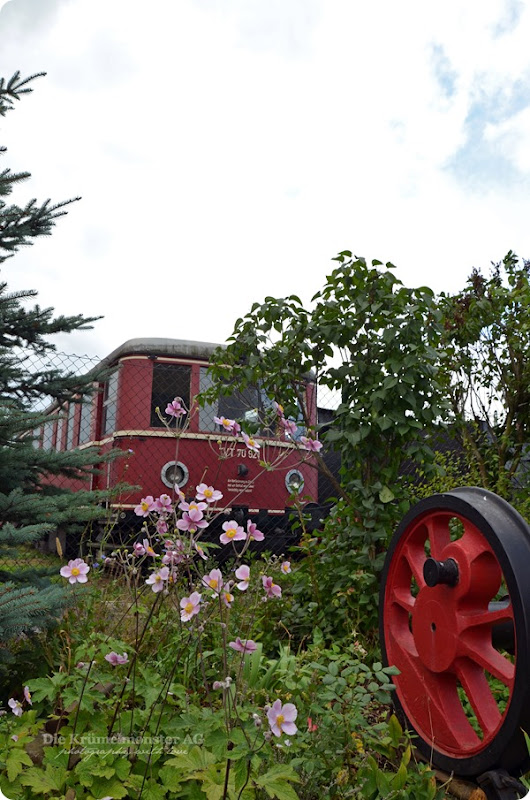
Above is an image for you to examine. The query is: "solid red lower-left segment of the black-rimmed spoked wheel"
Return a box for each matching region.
[384,634,480,751]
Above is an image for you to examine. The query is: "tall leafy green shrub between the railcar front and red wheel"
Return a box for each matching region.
[202,251,449,637]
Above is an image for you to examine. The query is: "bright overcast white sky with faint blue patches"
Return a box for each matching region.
[0,0,530,356]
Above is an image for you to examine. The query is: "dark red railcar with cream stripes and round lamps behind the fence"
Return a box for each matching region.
[38,339,318,544]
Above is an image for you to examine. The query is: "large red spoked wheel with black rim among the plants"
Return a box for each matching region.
[380,487,530,777]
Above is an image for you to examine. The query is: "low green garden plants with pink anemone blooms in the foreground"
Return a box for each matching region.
[0,398,436,800]
